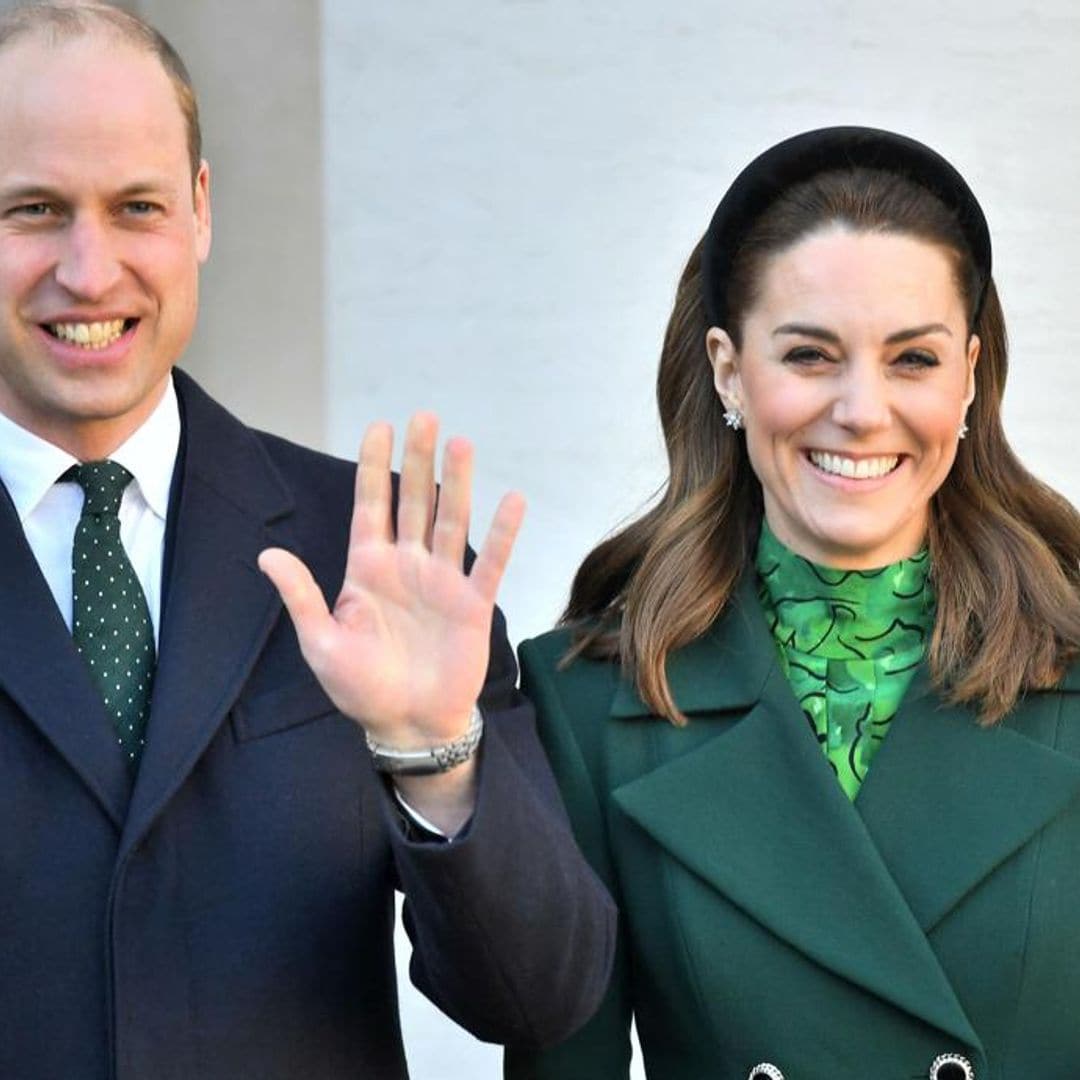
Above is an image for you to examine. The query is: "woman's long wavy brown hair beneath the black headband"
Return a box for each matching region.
[563,168,1080,724]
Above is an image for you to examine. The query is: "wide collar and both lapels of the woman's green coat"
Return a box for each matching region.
[611,576,1080,1052]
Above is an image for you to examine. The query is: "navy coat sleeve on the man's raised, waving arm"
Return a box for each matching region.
[384,610,616,1045]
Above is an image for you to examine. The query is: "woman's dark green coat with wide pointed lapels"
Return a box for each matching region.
[507,581,1080,1080]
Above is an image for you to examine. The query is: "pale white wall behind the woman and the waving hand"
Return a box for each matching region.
[321,0,1080,1080]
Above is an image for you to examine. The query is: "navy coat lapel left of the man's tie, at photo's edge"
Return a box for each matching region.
[0,485,131,832]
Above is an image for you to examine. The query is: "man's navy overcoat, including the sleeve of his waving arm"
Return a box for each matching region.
[0,374,613,1080]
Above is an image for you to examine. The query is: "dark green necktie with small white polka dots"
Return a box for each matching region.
[65,461,154,770]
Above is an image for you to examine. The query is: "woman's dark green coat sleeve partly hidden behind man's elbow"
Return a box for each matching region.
[504,642,632,1080]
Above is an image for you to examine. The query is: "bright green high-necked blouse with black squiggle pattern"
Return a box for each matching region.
[755,523,934,799]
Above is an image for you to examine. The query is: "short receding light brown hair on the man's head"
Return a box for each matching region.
[0,0,202,183]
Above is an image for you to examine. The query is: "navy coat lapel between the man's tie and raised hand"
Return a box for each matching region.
[122,373,293,849]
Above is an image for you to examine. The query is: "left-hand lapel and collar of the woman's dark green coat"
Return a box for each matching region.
[612,579,981,1049]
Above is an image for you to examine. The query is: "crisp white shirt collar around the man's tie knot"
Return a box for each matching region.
[0,376,180,523]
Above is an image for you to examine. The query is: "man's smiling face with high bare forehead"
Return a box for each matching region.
[0,32,211,460]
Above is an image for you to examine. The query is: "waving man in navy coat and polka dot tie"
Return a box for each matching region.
[0,3,613,1080]
